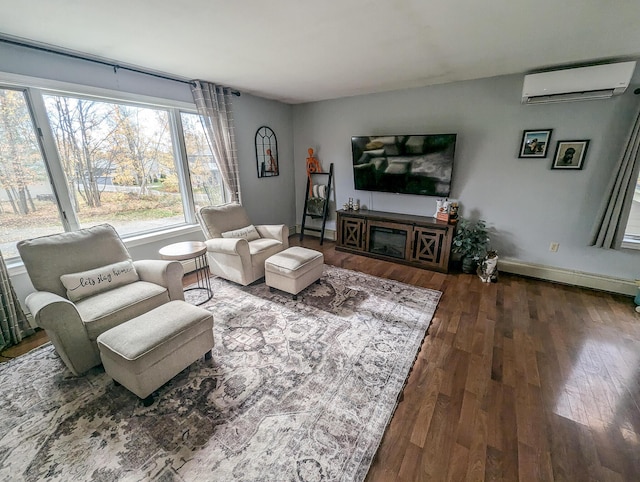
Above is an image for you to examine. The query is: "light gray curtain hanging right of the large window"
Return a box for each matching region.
[191,80,242,203]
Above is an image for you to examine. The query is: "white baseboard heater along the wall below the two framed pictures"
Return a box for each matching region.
[498,258,638,296]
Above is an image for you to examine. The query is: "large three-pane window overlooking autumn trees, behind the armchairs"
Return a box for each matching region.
[0,83,226,264]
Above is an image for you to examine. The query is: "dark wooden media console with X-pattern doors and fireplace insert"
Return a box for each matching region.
[336,209,454,273]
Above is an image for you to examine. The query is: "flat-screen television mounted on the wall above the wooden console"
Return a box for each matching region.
[351,134,456,197]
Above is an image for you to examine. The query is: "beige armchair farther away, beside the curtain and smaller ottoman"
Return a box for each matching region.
[197,203,289,286]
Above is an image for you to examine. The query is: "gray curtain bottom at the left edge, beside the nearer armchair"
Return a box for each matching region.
[0,253,33,350]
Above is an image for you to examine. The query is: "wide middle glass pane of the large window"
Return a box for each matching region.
[44,95,186,235]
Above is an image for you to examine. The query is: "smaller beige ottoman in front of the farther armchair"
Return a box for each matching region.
[264,246,324,300]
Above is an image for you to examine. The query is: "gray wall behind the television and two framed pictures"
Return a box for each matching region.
[293,75,640,280]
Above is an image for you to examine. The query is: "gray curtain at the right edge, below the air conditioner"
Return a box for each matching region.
[591,106,640,249]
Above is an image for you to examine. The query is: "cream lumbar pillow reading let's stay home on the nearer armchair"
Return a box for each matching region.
[60,261,140,301]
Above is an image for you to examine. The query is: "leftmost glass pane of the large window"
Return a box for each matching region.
[0,88,63,259]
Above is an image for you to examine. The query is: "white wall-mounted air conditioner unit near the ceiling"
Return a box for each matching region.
[522,62,636,104]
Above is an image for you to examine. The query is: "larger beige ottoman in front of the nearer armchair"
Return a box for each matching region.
[97,300,213,406]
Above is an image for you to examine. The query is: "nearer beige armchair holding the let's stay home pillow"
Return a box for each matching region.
[18,224,184,375]
